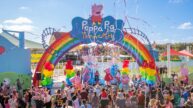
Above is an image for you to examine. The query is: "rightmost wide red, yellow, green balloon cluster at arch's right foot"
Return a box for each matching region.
[139,61,156,85]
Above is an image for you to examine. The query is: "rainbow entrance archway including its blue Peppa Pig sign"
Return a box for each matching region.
[33,13,155,86]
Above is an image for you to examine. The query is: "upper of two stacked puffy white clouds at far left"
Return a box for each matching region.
[3,17,32,24]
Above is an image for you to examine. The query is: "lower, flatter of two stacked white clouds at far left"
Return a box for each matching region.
[4,25,35,32]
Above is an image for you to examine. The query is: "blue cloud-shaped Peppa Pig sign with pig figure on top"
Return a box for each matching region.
[71,4,124,43]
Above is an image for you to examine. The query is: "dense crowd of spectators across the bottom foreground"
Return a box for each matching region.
[0,74,193,108]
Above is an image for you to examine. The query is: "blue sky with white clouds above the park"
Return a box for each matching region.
[0,0,193,43]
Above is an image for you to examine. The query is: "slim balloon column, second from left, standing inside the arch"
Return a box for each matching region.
[64,60,75,86]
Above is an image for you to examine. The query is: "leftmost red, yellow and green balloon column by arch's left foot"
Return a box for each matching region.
[41,62,54,88]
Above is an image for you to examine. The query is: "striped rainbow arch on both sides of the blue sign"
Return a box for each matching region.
[33,32,154,86]
